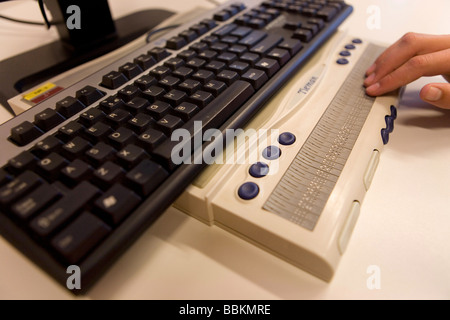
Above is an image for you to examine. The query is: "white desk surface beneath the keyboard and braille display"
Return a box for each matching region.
[0,0,450,300]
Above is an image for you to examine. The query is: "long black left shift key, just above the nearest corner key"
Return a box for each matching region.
[30,181,100,237]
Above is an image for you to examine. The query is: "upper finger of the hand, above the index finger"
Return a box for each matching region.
[364,33,450,87]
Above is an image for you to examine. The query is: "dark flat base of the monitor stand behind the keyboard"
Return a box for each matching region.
[0,9,174,115]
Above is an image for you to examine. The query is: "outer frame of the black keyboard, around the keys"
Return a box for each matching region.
[0,0,353,295]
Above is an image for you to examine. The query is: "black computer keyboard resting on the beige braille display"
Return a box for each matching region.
[0,0,352,293]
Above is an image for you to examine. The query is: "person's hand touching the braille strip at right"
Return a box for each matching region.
[364,32,450,109]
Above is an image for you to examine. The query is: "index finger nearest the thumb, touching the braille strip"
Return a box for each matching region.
[366,49,450,96]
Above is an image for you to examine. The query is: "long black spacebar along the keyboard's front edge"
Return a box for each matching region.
[153,80,255,171]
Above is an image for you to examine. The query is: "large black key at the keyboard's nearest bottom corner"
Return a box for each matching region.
[51,212,111,264]
